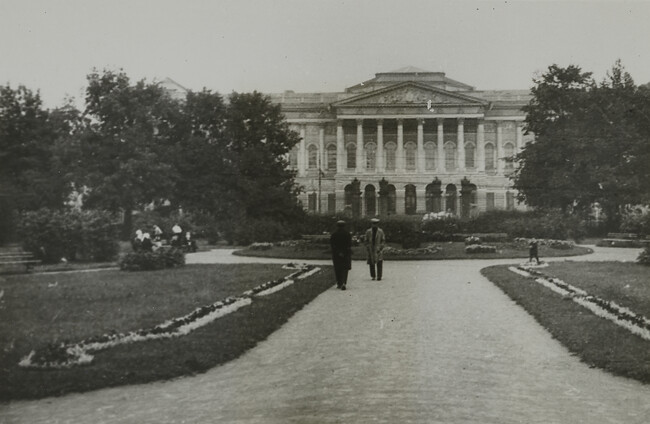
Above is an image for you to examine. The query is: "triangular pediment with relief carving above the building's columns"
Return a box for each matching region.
[333,82,487,107]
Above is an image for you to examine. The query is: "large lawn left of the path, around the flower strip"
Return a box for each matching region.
[0,265,332,401]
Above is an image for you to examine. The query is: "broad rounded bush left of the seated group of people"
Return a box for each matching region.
[19,209,119,263]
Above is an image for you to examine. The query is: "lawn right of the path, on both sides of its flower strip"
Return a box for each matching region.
[481,262,650,384]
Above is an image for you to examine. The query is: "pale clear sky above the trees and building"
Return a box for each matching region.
[0,0,650,108]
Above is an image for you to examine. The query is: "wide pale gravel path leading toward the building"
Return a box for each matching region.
[0,249,650,424]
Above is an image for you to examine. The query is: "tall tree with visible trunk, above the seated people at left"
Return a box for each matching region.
[77,70,179,238]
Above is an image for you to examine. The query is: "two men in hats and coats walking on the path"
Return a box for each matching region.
[330,218,386,290]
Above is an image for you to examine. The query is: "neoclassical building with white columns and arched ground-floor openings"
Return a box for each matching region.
[269,67,532,217]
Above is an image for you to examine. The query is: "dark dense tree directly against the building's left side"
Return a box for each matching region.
[176,90,301,227]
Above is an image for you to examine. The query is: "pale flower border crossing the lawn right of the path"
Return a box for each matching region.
[508,265,650,341]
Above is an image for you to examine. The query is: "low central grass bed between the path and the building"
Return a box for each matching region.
[235,242,591,260]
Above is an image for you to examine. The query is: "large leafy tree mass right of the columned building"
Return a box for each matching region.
[513,62,650,227]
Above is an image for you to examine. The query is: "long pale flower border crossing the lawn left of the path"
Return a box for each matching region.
[19,263,320,369]
